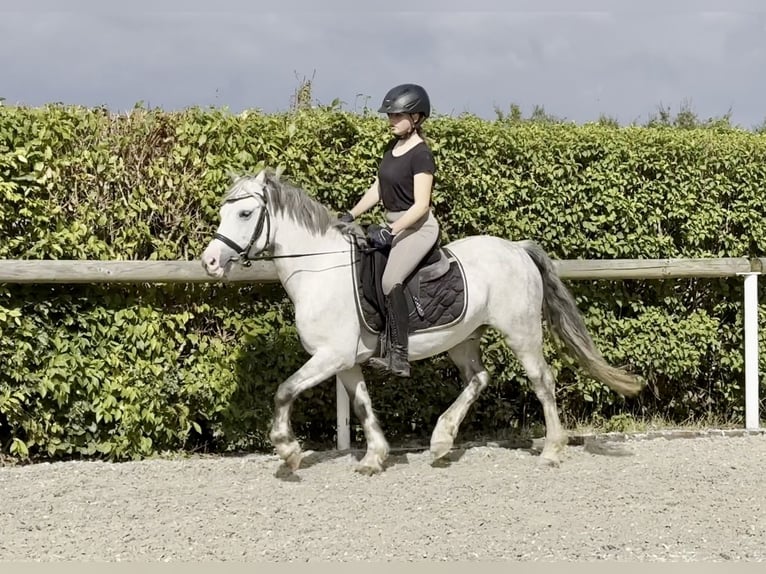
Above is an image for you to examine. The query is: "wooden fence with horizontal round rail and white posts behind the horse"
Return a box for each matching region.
[0,257,766,450]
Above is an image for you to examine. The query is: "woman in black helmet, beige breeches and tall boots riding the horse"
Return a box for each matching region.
[340,84,439,377]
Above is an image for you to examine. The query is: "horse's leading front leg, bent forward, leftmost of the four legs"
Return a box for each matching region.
[269,351,346,470]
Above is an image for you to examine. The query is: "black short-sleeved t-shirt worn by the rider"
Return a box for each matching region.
[378,140,436,211]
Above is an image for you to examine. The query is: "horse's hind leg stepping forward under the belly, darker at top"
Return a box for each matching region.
[431,330,489,459]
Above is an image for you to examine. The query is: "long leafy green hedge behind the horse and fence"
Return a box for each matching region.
[0,106,766,459]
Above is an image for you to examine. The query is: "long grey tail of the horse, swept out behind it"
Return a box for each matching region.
[521,241,643,395]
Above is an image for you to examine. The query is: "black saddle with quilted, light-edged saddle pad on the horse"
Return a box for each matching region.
[351,231,466,334]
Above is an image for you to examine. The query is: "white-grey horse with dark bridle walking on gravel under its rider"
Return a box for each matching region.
[201,169,643,475]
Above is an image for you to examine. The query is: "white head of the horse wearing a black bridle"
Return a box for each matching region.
[202,170,273,278]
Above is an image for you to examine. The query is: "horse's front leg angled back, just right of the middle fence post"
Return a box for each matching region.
[338,365,388,474]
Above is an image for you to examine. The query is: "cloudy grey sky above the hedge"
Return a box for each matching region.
[0,0,766,128]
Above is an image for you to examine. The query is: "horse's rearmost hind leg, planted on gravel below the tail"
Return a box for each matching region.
[505,328,567,466]
